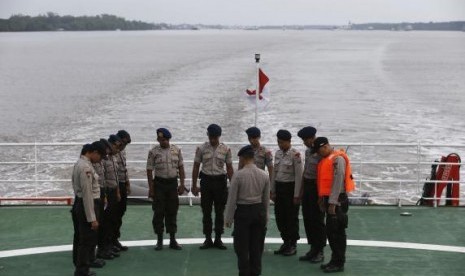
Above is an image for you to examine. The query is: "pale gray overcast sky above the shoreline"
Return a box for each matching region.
[0,0,465,25]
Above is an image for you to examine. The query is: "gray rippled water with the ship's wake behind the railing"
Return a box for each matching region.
[0,30,465,203]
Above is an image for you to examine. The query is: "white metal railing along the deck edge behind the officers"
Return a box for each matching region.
[0,142,465,205]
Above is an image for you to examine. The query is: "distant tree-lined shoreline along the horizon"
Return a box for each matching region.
[0,12,465,32]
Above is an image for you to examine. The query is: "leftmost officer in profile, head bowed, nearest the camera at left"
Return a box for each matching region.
[71,142,105,276]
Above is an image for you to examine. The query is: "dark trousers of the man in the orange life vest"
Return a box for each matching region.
[325,193,349,265]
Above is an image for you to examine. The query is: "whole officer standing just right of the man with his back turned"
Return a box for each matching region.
[271,129,302,256]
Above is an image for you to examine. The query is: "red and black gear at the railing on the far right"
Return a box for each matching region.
[417,153,461,206]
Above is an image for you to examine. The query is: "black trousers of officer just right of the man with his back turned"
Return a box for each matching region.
[274,181,300,242]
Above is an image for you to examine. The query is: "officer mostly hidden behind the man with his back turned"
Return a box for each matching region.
[239,127,273,179]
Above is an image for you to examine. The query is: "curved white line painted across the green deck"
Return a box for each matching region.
[0,238,465,258]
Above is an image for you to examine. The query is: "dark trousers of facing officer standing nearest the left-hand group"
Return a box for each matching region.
[152,177,179,235]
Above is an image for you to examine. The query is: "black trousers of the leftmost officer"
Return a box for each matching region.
[71,197,100,276]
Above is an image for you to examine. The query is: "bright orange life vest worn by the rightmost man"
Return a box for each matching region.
[317,150,355,196]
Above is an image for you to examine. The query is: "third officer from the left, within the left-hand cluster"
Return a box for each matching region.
[97,134,121,259]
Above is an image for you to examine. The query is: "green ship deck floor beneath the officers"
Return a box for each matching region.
[0,205,465,276]
